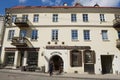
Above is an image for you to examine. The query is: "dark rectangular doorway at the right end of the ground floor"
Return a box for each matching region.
[101,55,114,74]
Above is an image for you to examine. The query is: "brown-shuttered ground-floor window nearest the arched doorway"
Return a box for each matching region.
[70,50,82,67]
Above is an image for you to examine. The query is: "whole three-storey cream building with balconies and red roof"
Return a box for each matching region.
[1,5,120,74]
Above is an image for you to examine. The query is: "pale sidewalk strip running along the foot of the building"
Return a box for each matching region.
[0,69,120,80]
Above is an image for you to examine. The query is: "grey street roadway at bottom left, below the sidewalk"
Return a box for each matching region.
[0,72,85,80]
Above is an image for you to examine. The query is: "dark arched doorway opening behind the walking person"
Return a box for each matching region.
[50,55,63,71]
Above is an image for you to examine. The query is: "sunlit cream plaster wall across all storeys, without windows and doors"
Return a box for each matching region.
[2,13,120,73]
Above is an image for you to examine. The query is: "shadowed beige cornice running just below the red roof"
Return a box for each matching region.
[7,7,120,14]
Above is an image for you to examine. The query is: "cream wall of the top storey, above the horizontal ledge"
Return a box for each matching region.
[13,13,114,25]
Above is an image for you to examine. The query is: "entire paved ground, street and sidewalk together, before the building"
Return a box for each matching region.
[0,69,120,80]
